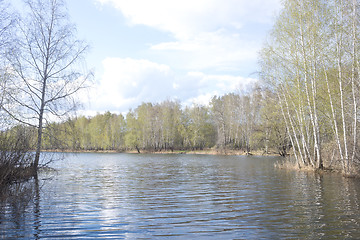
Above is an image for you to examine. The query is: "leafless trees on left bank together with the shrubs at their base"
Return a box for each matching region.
[0,0,88,183]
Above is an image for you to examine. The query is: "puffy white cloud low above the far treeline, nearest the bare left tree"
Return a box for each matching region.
[90,58,172,112]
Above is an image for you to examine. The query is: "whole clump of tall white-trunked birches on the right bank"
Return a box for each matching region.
[261,0,360,174]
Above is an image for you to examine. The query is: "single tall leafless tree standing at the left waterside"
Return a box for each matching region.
[3,0,88,173]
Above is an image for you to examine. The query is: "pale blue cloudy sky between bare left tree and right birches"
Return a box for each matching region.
[67,0,281,115]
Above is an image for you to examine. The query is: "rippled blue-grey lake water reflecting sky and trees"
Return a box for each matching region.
[0,153,360,239]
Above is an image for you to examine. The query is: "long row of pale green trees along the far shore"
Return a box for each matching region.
[38,87,290,156]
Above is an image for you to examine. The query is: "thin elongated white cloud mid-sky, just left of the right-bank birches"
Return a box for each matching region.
[151,30,261,71]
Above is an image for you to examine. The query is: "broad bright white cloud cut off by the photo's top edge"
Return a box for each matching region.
[97,0,280,40]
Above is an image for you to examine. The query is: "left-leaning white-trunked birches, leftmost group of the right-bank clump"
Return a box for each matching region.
[263,0,323,168]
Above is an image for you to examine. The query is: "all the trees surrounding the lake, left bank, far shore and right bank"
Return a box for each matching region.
[0,0,360,184]
